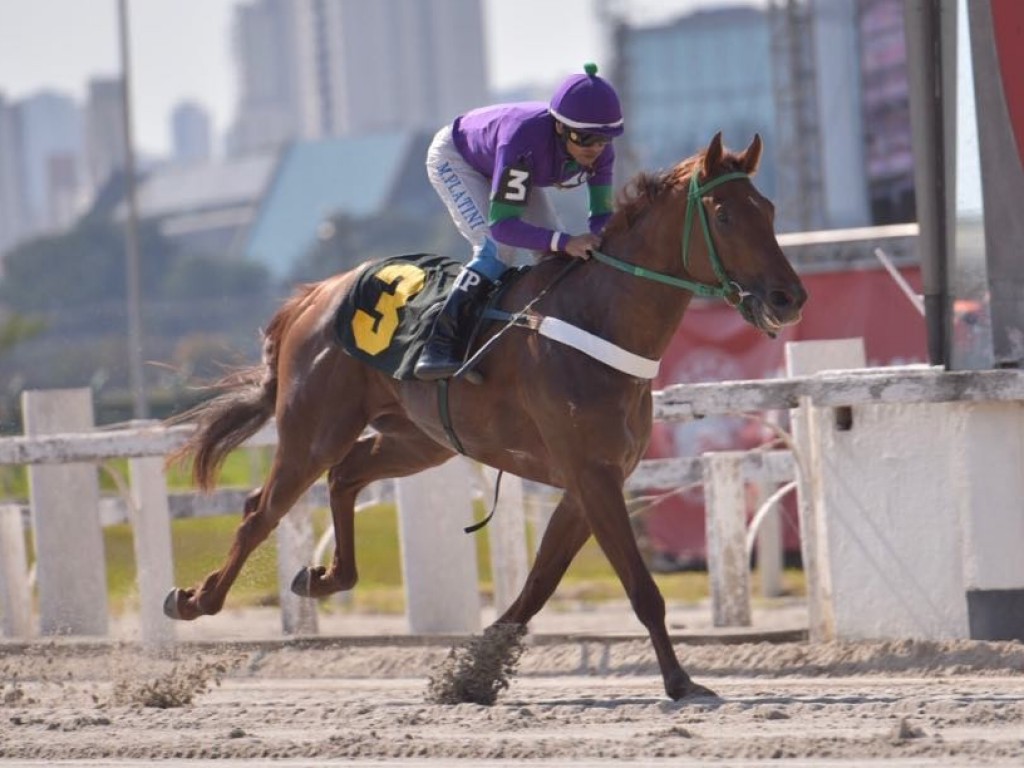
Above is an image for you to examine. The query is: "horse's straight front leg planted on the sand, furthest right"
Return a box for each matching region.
[571,466,714,700]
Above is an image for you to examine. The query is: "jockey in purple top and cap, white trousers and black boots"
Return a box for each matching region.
[414,63,623,381]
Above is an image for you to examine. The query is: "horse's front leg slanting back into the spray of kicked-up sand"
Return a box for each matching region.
[495,494,590,626]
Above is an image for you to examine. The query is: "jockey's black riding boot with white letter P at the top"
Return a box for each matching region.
[413,268,490,381]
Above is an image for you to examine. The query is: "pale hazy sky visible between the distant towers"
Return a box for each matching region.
[0,0,737,155]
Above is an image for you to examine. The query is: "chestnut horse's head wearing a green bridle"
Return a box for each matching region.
[683,133,807,336]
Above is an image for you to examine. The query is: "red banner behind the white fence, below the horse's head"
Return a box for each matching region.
[643,268,928,567]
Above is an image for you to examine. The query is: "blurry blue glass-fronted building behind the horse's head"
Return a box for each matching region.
[615,0,876,231]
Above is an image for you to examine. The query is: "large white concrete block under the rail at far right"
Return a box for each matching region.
[791,343,1024,640]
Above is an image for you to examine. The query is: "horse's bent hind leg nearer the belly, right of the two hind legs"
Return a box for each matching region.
[292,417,455,597]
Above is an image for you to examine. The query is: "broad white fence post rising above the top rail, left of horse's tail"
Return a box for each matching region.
[22,389,109,635]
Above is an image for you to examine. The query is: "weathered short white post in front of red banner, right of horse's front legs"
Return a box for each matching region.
[701,451,751,627]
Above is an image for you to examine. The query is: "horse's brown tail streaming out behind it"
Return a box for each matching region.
[167,286,314,490]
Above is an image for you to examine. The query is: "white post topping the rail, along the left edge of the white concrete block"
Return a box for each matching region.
[785,338,866,642]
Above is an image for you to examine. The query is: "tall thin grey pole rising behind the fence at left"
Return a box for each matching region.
[118,0,148,419]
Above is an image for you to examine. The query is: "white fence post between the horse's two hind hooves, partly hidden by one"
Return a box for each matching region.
[276,496,319,635]
